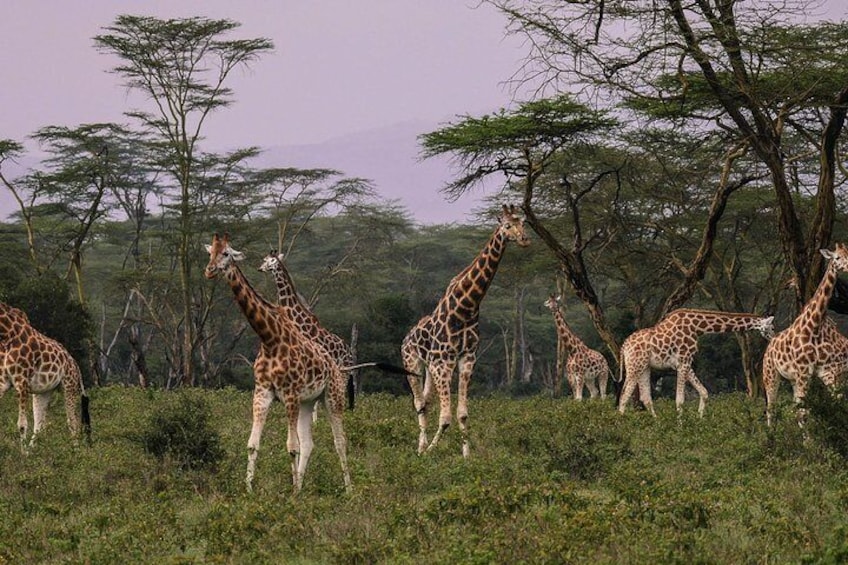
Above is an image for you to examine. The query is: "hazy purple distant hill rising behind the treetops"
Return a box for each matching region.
[0,122,501,224]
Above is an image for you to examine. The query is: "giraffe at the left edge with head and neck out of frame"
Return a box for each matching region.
[0,302,91,449]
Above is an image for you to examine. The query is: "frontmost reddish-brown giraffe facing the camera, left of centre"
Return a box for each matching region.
[205,233,351,492]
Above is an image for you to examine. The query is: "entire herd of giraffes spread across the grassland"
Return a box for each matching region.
[0,206,848,492]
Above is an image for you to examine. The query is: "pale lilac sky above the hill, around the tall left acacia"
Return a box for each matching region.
[0,0,524,149]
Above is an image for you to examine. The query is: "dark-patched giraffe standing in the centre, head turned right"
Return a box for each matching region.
[401,205,530,457]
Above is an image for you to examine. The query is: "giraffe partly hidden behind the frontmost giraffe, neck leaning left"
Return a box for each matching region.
[259,250,356,416]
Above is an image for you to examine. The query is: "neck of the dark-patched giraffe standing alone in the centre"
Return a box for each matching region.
[441,230,507,319]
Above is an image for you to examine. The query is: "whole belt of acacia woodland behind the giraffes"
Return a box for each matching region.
[0,0,848,406]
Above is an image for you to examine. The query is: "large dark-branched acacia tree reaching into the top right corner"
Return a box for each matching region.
[488,0,848,305]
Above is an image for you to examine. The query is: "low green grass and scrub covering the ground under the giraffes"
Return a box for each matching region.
[0,387,848,564]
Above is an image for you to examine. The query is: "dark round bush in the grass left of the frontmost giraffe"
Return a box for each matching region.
[140,391,223,470]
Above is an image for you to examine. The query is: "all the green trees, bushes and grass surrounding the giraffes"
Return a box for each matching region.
[0,0,848,563]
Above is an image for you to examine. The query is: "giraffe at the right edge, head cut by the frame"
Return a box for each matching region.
[763,243,848,426]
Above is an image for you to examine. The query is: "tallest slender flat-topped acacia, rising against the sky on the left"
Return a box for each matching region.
[94,15,273,384]
